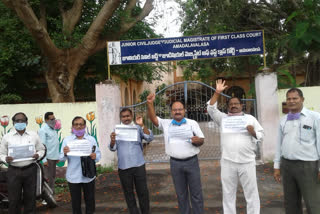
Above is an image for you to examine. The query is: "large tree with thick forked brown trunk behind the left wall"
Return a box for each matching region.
[2,0,153,102]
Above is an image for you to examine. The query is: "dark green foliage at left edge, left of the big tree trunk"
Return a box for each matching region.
[0,2,41,103]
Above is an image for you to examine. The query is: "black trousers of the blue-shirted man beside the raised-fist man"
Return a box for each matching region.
[118,165,150,214]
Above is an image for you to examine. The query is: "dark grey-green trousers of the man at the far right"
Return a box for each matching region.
[281,158,320,214]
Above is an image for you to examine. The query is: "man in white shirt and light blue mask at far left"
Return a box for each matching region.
[0,112,45,213]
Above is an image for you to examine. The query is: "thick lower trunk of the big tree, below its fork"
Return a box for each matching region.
[45,51,82,103]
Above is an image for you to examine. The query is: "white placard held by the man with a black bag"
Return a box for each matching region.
[67,139,92,156]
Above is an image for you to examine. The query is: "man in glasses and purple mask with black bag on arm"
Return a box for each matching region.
[60,116,101,214]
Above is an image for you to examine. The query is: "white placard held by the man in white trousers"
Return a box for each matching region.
[221,116,247,133]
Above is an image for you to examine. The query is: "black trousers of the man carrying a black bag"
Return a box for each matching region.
[68,180,96,214]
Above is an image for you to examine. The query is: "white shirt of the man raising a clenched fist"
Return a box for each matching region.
[157,117,204,159]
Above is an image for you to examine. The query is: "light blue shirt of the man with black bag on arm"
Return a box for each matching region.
[60,134,101,183]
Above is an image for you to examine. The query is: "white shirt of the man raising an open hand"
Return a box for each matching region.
[207,103,264,163]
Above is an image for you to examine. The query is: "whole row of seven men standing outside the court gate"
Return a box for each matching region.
[0,79,320,214]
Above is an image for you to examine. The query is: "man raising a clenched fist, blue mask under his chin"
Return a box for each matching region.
[147,94,204,214]
